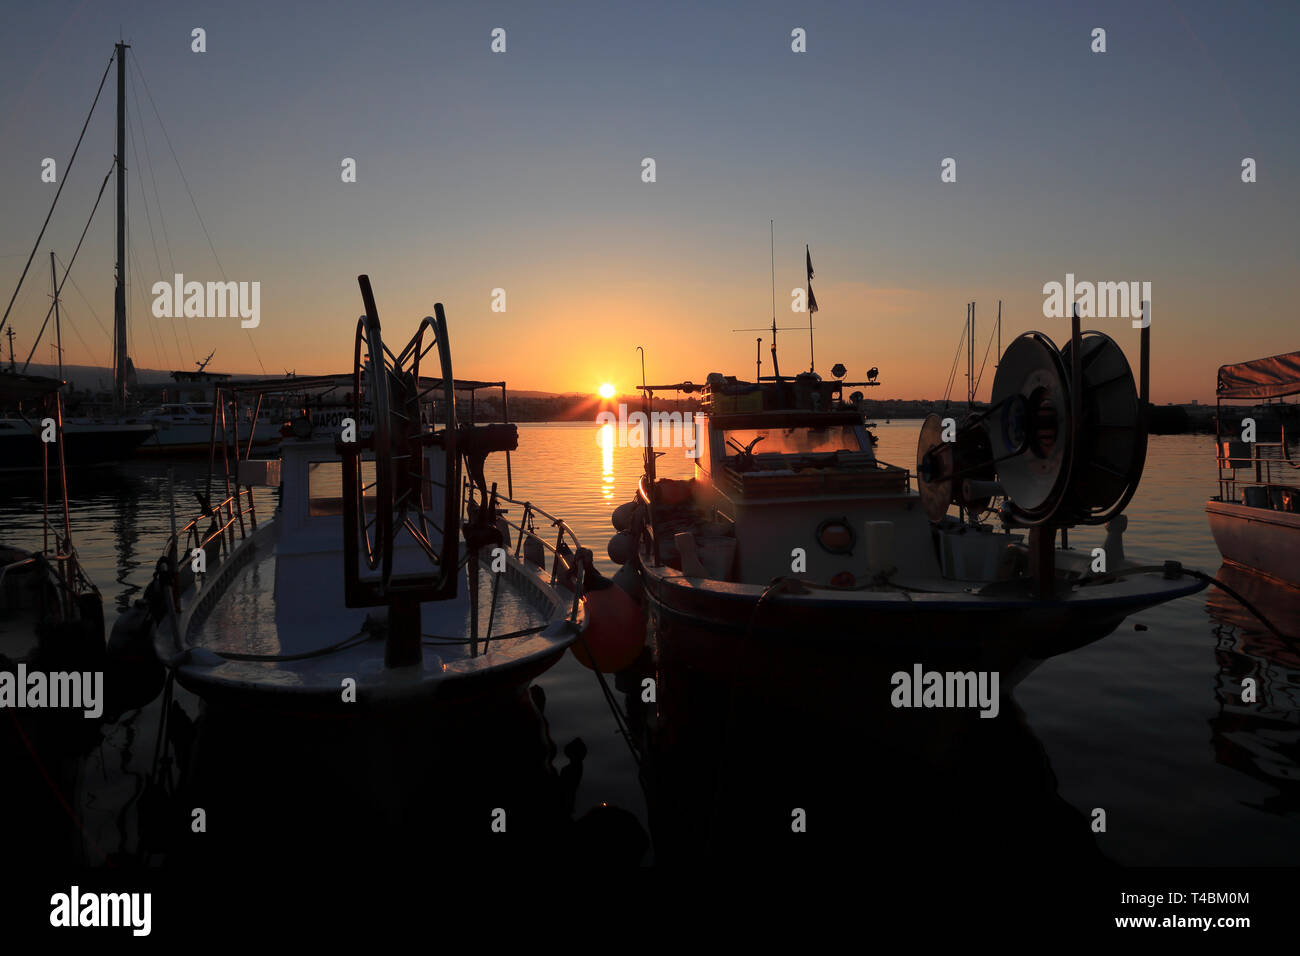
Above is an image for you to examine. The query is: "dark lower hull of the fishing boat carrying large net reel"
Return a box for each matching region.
[642,567,1205,706]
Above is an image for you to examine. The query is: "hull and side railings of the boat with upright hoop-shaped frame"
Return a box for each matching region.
[152,516,579,715]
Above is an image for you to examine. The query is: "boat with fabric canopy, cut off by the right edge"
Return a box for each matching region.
[1205,351,1300,588]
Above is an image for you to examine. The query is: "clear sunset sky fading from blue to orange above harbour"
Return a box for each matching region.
[0,0,1300,403]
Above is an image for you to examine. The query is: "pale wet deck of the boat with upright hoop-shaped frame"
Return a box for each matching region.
[165,535,573,710]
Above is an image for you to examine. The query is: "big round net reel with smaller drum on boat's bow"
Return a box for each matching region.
[917,316,1149,528]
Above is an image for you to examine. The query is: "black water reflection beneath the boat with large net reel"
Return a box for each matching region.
[628,660,1106,866]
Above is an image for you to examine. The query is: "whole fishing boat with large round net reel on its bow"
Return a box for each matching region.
[610,306,1205,701]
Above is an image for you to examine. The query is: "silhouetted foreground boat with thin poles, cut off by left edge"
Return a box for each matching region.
[0,373,104,666]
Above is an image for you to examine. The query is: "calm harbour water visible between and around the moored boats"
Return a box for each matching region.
[0,421,1300,865]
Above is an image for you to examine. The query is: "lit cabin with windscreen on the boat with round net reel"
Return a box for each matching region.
[645,376,939,587]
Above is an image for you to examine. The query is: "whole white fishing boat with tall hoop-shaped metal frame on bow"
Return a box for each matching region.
[122,276,590,714]
